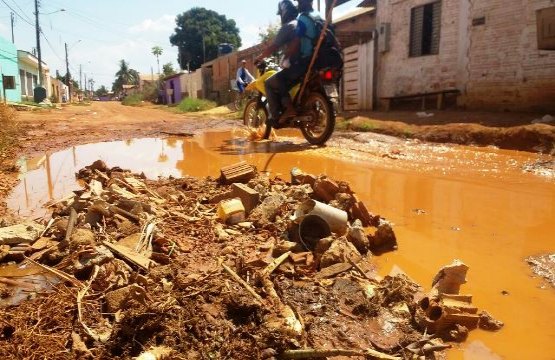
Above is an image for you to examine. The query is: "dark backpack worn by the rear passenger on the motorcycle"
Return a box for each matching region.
[301,13,343,70]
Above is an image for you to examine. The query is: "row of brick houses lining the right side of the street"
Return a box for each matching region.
[159,0,555,111]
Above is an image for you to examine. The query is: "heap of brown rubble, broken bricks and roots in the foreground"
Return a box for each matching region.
[0,161,502,360]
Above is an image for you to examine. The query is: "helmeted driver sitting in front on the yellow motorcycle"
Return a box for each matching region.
[256,0,316,128]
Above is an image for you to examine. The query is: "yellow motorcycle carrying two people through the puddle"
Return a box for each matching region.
[243,63,341,145]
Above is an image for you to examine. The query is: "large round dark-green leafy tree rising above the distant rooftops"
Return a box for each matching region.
[170,7,241,70]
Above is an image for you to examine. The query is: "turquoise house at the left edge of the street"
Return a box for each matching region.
[0,37,21,102]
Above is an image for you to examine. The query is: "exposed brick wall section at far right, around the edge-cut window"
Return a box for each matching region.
[462,0,555,111]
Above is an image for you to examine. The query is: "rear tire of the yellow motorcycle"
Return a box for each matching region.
[301,92,335,145]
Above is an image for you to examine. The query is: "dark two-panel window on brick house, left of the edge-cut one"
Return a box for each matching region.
[409,1,441,57]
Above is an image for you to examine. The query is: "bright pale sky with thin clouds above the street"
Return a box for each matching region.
[0,0,360,89]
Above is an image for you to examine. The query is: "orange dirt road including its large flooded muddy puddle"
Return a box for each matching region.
[0,103,555,360]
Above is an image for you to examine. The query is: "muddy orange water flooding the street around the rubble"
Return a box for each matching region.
[5,132,555,360]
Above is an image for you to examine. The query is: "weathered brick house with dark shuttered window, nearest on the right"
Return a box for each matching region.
[374,0,555,111]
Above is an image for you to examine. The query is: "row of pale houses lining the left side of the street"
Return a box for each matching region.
[0,37,69,103]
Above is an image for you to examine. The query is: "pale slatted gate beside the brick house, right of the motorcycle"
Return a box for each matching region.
[343,41,374,111]
